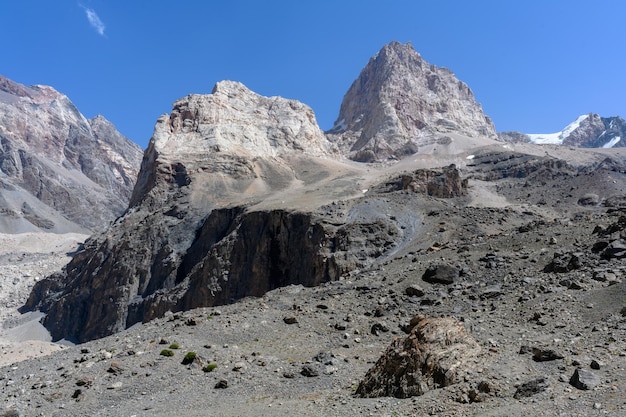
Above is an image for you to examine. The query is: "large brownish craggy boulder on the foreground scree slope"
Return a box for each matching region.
[356,317,480,398]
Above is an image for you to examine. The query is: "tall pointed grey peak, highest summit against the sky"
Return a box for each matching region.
[327,42,496,161]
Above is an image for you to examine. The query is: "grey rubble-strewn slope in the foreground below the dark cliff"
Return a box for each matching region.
[2,154,626,416]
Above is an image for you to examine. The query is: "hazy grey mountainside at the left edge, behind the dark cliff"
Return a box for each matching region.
[0,76,142,233]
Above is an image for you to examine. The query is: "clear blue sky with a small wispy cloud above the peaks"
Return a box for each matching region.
[0,0,626,148]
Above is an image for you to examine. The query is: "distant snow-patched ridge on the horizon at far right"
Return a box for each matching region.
[498,113,626,148]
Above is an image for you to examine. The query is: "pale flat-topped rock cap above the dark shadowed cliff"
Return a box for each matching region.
[154,81,330,156]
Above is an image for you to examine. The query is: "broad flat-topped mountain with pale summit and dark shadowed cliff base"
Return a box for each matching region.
[25,82,466,342]
